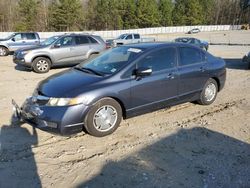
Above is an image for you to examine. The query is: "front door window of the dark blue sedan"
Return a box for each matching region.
[138,48,176,71]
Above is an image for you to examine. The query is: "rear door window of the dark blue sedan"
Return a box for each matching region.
[179,47,202,66]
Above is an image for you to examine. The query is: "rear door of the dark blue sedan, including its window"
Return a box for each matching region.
[178,47,208,97]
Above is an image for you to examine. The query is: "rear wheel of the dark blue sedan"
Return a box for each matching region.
[197,78,218,105]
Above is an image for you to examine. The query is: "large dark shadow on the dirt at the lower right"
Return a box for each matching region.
[77,128,250,188]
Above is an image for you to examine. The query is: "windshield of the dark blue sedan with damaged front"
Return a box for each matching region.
[78,46,142,74]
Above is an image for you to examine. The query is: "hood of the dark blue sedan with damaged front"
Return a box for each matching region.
[38,68,104,98]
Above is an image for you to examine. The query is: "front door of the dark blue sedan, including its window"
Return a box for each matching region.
[131,47,178,111]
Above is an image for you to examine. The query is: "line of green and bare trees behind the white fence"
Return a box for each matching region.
[0,0,250,31]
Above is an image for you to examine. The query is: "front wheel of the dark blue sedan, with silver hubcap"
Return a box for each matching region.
[84,98,122,137]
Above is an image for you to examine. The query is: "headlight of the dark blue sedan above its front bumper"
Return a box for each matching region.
[47,97,88,106]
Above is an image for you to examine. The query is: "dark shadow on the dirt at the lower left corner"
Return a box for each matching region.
[0,117,42,188]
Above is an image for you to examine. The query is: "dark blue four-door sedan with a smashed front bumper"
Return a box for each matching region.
[13,43,226,137]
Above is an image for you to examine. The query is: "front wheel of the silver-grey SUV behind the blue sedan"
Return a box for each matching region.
[32,57,51,73]
